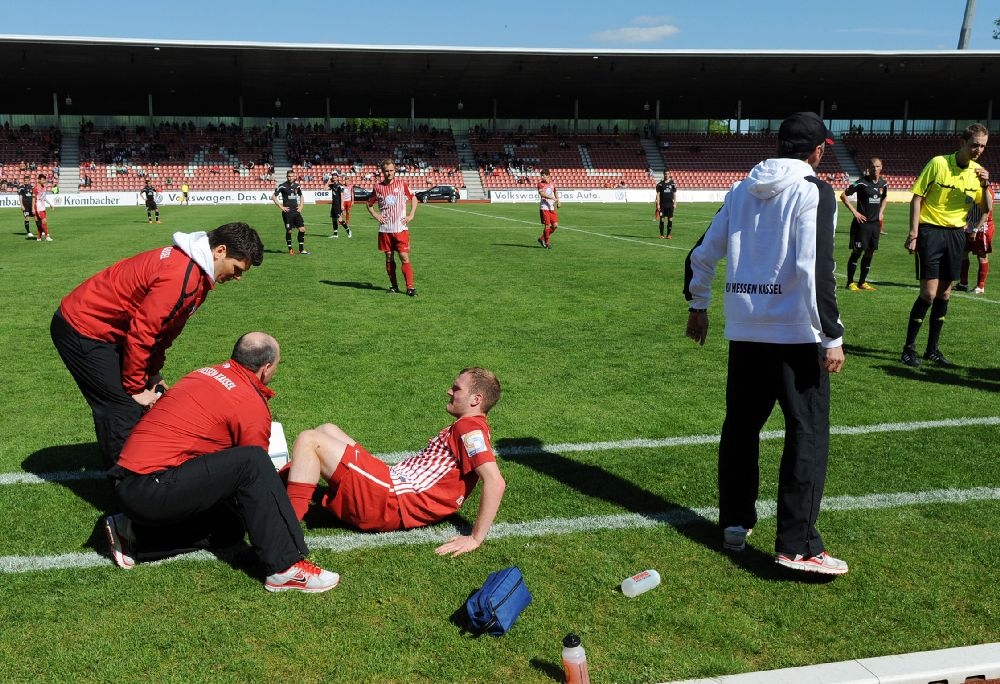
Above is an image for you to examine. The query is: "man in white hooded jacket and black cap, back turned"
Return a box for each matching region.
[684,112,848,575]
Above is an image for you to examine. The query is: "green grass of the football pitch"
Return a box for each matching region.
[0,196,1000,684]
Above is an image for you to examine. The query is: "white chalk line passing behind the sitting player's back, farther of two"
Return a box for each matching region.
[0,416,1000,485]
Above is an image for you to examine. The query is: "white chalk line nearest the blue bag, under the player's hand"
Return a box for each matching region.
[0,487,1000,574]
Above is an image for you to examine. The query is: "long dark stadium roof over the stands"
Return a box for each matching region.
[0,35,1000,121]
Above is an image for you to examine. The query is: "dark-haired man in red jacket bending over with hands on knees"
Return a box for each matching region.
[50,223,264,466]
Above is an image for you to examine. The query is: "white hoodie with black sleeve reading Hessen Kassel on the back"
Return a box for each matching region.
[684,158,844,348]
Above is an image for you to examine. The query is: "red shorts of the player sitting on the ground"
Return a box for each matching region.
[322,444,403,532]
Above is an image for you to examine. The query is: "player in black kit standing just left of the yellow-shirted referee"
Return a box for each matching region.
[840,157,889,292]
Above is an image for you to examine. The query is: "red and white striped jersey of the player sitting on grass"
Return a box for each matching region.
[389,416,496,528]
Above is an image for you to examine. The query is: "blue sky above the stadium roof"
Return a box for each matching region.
[0,0,1000,51]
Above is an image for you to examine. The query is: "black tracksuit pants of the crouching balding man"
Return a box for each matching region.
[111,447,309,575]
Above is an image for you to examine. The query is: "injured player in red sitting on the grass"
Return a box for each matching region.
[287,368,507,556]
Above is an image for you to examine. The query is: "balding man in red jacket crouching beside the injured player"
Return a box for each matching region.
[104,332,340,592]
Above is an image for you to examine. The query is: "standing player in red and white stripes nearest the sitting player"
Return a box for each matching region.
[368,159,418,297]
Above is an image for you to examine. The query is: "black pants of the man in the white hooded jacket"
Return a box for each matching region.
[719,341,830,556]
